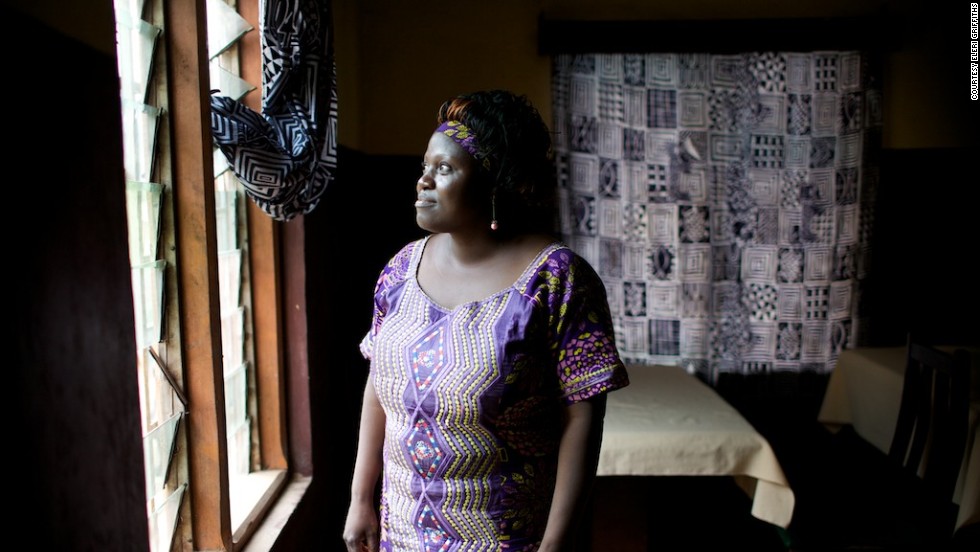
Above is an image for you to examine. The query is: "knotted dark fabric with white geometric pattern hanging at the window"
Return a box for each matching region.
[211,0,337,221]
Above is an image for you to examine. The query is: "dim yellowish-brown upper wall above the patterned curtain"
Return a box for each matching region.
[333,0,976,155]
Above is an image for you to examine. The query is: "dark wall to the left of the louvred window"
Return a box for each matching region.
[7,8,149,552]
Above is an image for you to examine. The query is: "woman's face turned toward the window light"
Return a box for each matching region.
[415,132,489,233]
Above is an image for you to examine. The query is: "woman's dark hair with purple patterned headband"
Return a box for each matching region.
[436,90,557,235]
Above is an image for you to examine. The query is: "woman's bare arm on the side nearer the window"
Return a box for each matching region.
[344,376,385,552]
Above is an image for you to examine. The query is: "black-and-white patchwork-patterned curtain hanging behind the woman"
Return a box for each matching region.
[553,51,881,383]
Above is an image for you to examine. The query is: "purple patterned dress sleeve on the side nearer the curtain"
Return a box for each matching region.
[544,249,629,404]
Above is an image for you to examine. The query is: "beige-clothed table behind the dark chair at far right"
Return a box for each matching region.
[817,346,980,528]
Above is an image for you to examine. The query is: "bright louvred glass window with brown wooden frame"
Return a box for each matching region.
[115,0,288,552]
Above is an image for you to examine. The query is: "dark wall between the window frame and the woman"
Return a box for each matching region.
[276,147,422,552]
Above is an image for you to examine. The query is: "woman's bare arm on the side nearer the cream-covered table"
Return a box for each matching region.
[539,394,606,552]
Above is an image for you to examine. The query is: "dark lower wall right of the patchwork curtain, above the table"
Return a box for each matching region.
[866,147,980,346]
